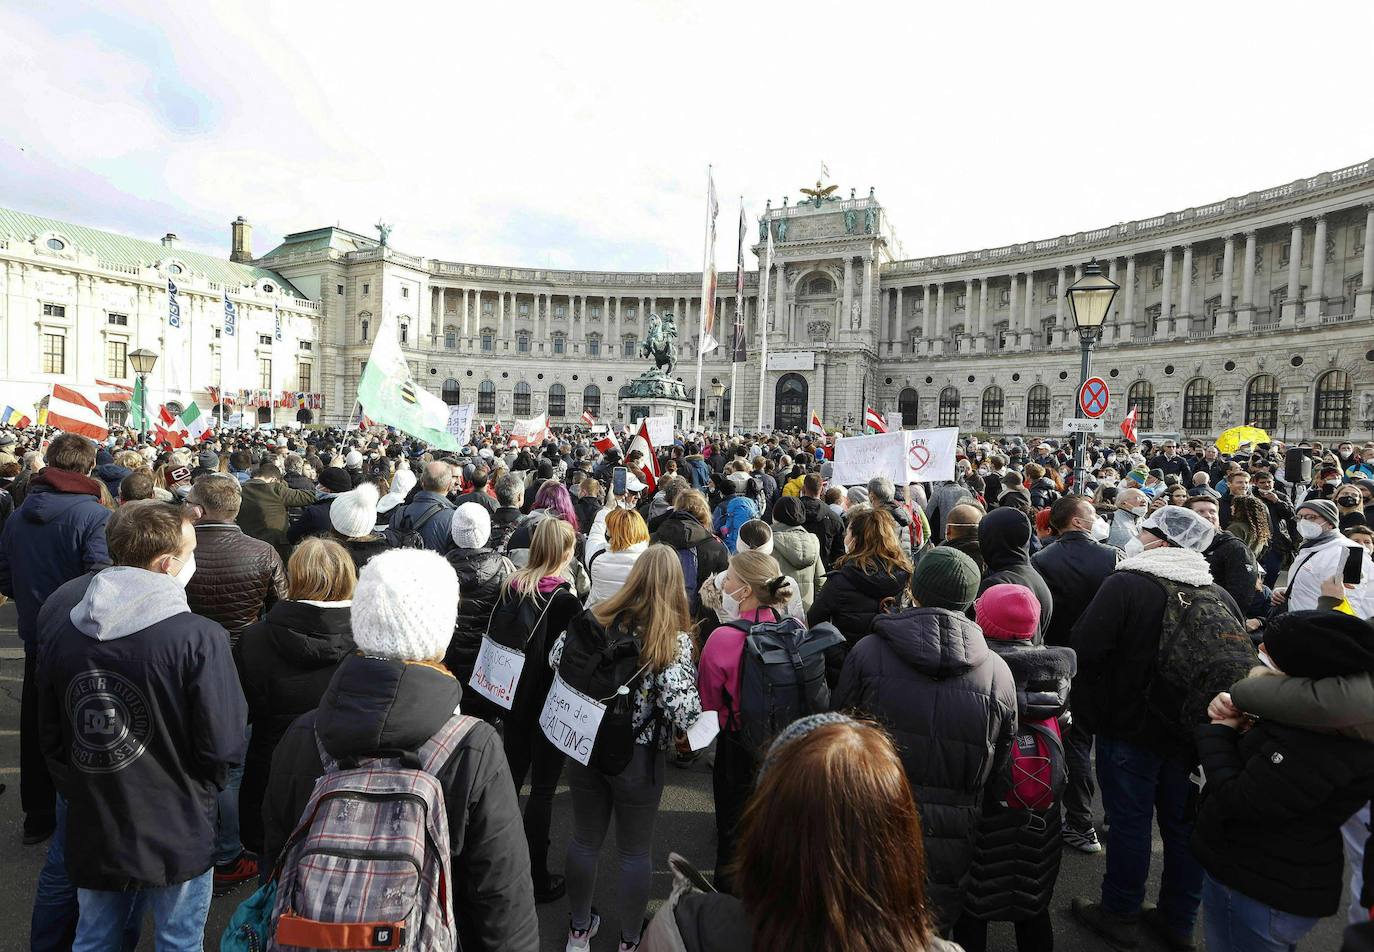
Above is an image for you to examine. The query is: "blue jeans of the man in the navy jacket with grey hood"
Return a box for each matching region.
[71,870,214,952]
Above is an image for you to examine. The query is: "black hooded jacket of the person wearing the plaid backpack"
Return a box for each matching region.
[262,654,539,952]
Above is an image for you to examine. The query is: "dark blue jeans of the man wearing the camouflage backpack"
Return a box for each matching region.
[1098,734,1202,936]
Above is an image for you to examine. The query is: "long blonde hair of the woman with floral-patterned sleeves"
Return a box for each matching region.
[591,545,691,673]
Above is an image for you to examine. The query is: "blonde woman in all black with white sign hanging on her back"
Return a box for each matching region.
[483,519,583,903]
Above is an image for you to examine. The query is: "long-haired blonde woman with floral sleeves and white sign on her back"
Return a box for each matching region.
[545,545,716,952]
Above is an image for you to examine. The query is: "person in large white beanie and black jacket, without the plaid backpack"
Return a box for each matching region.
[262,549,539,952]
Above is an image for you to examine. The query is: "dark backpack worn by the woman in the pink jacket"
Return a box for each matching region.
[725,611,845,751]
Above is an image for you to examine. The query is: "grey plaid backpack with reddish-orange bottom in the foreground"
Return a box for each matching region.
[268,712,478,952]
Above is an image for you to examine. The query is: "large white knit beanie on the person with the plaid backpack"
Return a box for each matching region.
[351,549,458,661]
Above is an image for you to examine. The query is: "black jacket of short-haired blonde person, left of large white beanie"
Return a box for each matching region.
[234,602,353,852]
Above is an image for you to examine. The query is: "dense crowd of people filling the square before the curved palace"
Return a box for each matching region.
[0,427,1374,952]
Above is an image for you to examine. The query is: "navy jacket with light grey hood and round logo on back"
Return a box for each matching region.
[36,566,247,890]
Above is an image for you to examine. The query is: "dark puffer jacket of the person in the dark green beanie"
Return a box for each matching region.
[822,609,1017,926]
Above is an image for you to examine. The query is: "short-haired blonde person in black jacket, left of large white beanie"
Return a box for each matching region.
[230,538,357,854]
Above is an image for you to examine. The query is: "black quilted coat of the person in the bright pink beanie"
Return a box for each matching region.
[965,639,1077,922]
